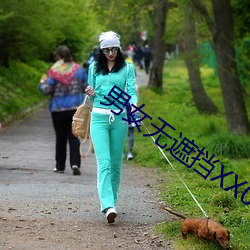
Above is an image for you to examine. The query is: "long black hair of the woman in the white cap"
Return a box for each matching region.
[96,49,126,75]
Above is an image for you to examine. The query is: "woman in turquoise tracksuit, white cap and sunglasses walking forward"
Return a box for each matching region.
[86,31,137,223]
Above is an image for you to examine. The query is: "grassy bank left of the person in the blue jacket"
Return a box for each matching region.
[0,61,48,124]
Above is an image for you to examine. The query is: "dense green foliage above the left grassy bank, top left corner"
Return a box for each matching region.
[0,0,99,67]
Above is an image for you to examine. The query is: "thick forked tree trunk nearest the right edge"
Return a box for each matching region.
[191,0,250,134]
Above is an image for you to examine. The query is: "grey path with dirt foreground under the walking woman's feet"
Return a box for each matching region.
[0,70,173,250]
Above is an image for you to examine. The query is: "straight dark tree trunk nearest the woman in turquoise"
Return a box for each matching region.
[148,0,168,89]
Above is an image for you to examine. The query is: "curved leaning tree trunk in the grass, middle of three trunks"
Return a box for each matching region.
[184,2,218,114]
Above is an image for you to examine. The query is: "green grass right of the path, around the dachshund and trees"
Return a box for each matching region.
[129,60,250,250]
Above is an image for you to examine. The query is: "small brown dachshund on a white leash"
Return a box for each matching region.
[163,207,230,249]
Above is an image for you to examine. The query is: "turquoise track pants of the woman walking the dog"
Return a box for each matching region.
[90,112,128,212]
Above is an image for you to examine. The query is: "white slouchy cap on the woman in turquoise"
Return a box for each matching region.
[99,31,121,49]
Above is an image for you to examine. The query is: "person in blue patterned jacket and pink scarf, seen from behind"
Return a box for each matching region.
[39,46,87,175]
